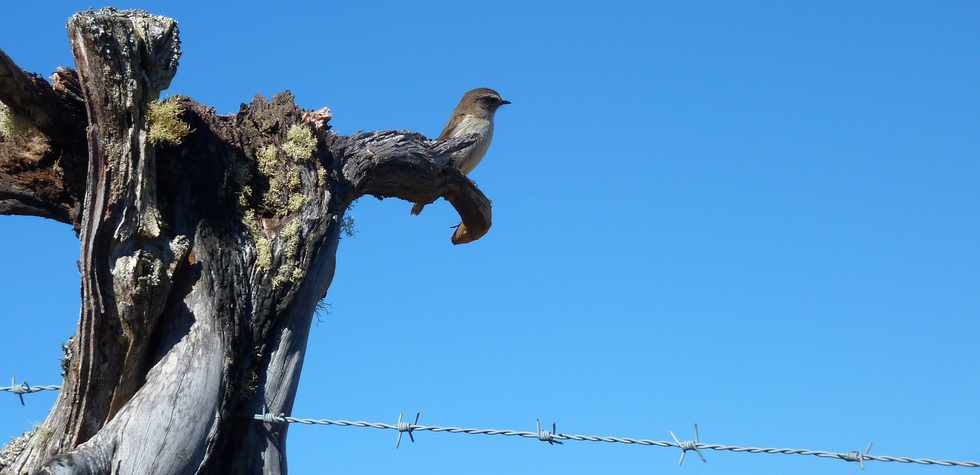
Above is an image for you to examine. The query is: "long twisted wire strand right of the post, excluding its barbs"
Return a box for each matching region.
[253,414,980,468]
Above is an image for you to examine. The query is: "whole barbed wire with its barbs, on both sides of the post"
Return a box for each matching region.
[9,379,980,469]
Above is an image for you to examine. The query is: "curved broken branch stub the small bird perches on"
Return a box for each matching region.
[331,131,491,244]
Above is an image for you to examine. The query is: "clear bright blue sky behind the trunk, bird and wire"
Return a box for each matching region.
[0,0,980,475]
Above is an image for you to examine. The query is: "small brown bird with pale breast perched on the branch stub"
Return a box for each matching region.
[412,87,510,214]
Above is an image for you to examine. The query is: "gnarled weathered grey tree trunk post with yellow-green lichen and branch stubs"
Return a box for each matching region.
[0,9,491,474]
